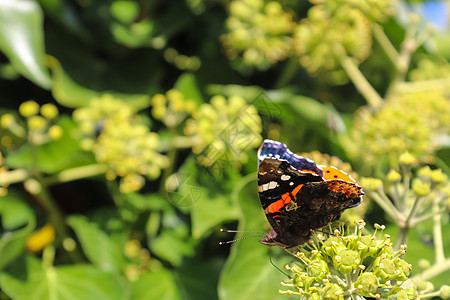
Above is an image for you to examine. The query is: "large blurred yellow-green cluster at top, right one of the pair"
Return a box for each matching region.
[294,0,392,83]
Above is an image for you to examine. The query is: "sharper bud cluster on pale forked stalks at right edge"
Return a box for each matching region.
[361,153,450,250]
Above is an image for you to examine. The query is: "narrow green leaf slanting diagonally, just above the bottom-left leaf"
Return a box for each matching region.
[67,216,126,272]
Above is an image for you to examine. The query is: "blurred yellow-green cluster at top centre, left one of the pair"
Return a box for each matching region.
[222,0,295,70]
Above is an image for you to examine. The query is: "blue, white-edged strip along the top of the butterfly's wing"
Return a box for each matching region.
[258,140,323,177]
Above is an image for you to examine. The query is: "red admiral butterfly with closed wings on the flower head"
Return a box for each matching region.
[258,140,364,249]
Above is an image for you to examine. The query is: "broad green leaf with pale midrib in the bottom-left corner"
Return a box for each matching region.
[0,256,130,300]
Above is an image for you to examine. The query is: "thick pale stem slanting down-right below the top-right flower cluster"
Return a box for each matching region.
[338,52,383,108]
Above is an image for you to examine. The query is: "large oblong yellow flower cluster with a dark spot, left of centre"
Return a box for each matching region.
[74,95,169,193]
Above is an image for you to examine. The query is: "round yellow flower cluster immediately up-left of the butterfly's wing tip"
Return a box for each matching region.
[185,96,262,167]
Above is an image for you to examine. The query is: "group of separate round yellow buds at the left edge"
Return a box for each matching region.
[0,100,63,147]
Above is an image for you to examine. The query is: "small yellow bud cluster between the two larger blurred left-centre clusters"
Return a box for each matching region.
[152,89,197,127]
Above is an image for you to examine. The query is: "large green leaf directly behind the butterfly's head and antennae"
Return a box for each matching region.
[218,179,289,300]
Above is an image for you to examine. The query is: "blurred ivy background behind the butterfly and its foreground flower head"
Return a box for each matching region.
[0,0,450,299]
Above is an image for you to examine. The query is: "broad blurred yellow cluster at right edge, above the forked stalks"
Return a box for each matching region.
[348,90,450,168]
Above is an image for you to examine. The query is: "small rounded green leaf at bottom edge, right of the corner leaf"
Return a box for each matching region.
[132,269,181,300]
